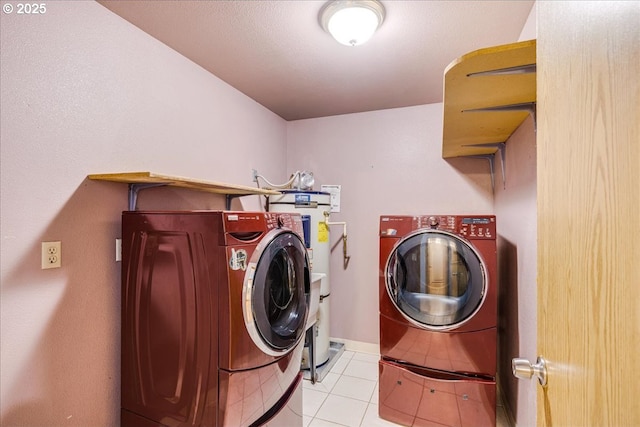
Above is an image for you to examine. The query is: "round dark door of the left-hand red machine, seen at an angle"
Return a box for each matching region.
[242,229,311,356]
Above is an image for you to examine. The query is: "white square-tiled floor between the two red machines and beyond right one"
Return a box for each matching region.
[302,351,510,427]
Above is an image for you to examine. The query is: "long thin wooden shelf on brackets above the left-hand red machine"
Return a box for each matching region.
[88,172,280,210]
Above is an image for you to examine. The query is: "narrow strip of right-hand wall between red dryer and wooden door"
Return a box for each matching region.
[495,4,538,426]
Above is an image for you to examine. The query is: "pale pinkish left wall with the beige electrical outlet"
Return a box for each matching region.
[0,1,286,427]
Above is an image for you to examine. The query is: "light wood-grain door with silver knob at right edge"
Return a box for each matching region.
[537,1,640,426]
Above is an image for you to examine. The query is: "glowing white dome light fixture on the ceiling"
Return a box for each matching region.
[320,0,384,46]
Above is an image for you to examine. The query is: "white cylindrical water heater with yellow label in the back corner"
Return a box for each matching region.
[269,190,331,366]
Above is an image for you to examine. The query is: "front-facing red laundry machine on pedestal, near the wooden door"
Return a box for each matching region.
[379,215,498,427]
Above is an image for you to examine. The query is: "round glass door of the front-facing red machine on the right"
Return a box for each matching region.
[385,230,488,330]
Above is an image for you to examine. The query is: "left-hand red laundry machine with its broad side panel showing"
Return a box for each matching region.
[121,211,310,427]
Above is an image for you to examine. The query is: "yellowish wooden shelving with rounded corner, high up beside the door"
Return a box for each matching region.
[442,40,536,158]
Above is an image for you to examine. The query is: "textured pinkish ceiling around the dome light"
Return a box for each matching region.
[99,0,534,120]
